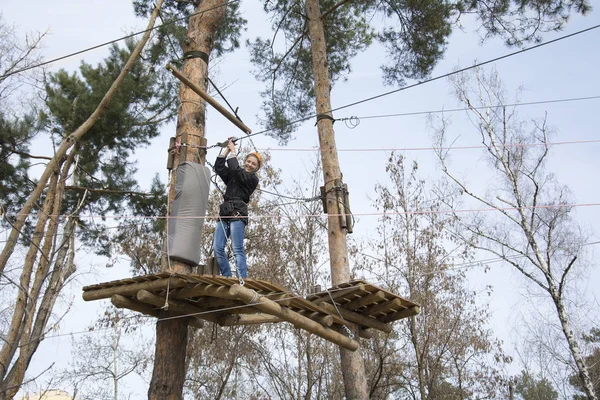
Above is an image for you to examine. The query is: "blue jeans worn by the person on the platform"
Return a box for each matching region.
[214,219,247,278]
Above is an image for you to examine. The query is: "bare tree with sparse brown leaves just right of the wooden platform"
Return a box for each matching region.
[359,154,509,399]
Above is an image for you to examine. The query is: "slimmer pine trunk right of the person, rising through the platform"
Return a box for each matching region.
[306,0,368,400]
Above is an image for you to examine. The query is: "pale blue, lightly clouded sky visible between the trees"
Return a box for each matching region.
[0,0,600,393]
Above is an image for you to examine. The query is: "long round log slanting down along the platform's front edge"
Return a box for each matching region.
[229,284,358,351]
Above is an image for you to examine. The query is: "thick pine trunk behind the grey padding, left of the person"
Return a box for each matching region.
[148,0,226,400]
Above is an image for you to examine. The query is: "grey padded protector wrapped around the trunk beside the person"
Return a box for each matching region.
[168,162,210,266]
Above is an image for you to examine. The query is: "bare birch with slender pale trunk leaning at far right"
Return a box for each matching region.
[436,69,597,400]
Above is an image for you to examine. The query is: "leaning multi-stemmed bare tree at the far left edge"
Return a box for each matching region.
[0,0,162,400]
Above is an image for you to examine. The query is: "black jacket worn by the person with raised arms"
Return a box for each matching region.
[215,157,258,224]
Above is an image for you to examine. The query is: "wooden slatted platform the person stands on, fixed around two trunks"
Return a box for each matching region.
[83,273,419,350]
